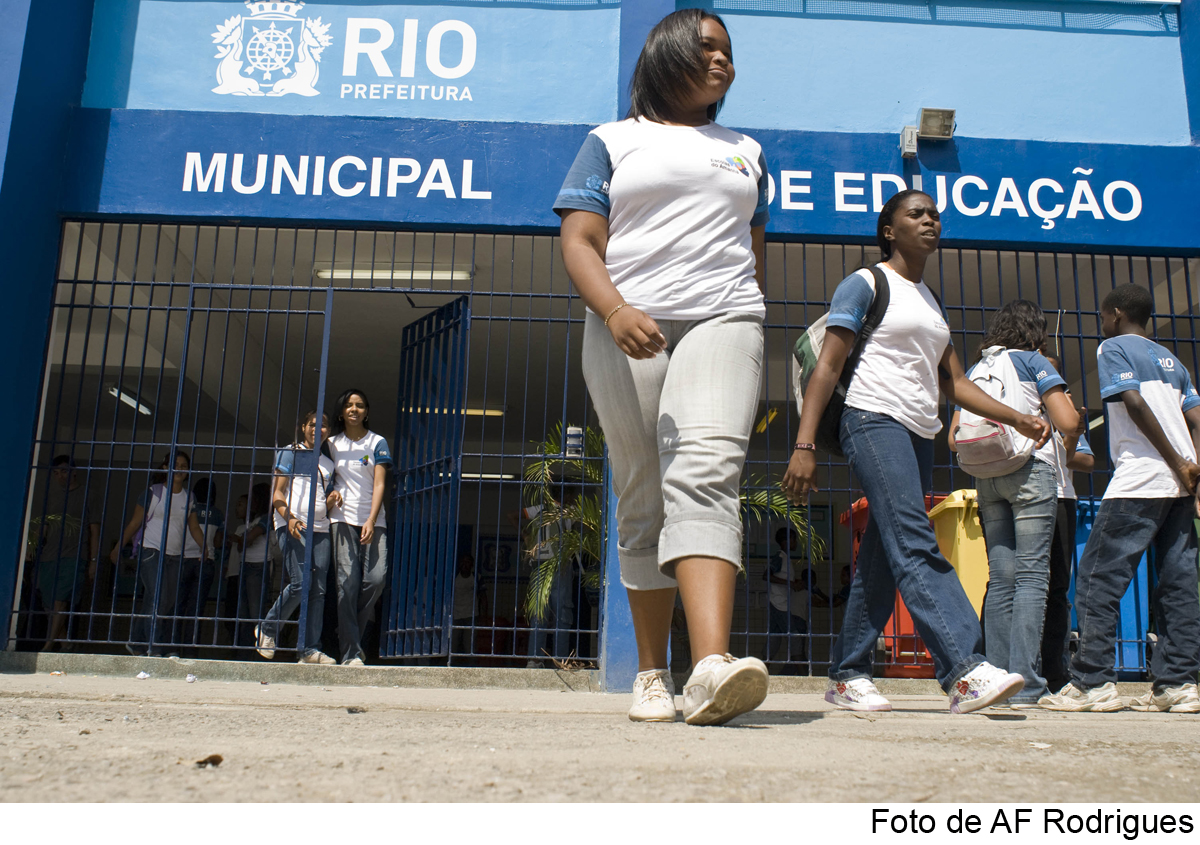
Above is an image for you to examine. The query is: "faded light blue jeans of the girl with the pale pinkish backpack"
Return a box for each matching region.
[976,457,1058,703]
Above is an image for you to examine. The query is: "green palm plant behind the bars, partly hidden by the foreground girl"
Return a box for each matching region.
[523,424,824,619]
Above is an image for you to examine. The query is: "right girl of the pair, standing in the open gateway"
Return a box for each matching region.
[329,389,391,666]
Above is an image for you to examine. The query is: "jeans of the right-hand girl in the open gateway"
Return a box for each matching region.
[330,522,388,663]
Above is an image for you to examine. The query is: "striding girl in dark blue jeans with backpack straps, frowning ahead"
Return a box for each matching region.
[782,191,1050,713]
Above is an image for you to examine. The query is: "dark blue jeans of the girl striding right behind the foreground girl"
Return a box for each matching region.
[829,408,984,690]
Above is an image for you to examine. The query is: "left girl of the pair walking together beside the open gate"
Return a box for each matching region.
[254,410,337,665]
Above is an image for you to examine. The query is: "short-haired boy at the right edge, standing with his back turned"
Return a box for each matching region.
[1038,284,1200,713]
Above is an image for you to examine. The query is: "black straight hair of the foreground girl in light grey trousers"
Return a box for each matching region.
[625,8,733,124]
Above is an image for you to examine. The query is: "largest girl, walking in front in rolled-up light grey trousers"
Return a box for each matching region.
[554,8,768,725]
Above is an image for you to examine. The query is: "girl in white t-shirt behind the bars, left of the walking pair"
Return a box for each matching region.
[108,450,205,657]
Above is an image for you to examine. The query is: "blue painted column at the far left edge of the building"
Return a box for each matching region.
[0,0,92,647]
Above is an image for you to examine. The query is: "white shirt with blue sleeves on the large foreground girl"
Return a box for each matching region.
[554,119,769,320]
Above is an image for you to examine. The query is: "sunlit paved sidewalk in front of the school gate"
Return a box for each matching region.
[0,670,1200,802]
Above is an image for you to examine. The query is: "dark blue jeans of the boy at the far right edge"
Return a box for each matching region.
[1070,496,1200,689]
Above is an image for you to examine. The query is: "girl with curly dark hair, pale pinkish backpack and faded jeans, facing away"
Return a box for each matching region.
[948,299,1079,708]
